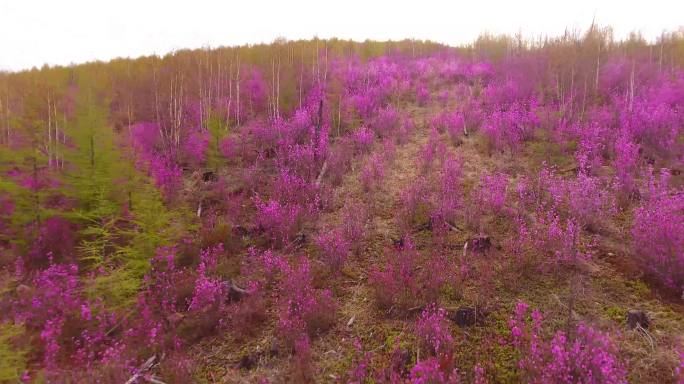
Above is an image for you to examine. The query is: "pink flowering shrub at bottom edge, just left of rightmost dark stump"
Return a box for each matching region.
[509,302,627,383]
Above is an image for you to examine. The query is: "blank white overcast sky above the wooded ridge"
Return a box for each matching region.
[0,0,684,70]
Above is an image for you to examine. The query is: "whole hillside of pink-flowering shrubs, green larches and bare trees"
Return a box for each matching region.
[0,26,684,384]
